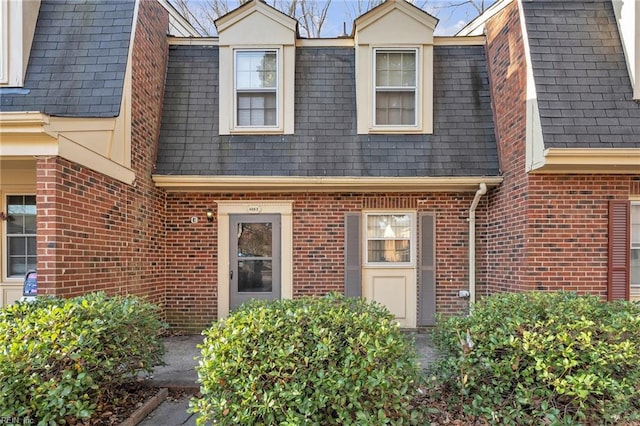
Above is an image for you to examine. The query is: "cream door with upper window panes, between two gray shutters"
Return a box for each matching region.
[363,211,417,328]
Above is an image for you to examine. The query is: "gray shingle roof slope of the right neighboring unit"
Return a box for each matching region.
[523,0,640,148]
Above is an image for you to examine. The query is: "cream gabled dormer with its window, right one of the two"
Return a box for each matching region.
[354,0,438,135]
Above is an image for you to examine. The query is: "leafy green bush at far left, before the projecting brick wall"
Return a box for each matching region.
[0,293,164,424]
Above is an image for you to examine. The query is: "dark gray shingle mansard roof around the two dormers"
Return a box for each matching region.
[156,46,498,177]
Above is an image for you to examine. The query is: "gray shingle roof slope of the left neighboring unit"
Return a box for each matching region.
[0,0,135,117]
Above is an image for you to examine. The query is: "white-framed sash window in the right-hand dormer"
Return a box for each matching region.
[373,49,419,127]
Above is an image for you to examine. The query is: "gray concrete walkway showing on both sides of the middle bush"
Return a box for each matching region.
[139,332,437,426]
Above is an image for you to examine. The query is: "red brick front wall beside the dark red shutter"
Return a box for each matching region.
[527,175,634,297]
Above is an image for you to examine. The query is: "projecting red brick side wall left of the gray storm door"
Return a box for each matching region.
[36,1,168,303]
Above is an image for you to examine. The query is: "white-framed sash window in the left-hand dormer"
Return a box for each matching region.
[234,49,279,128]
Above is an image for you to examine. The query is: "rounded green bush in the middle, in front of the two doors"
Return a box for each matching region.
[191,295,419,425]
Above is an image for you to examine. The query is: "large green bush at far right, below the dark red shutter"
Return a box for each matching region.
[434,292,640,424]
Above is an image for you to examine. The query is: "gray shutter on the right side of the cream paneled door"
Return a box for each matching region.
[418,213,436,325]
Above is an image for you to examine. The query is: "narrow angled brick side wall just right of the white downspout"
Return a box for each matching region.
[484,2,530,295]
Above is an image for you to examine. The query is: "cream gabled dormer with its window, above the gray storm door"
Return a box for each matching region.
[214,0,297,135]
